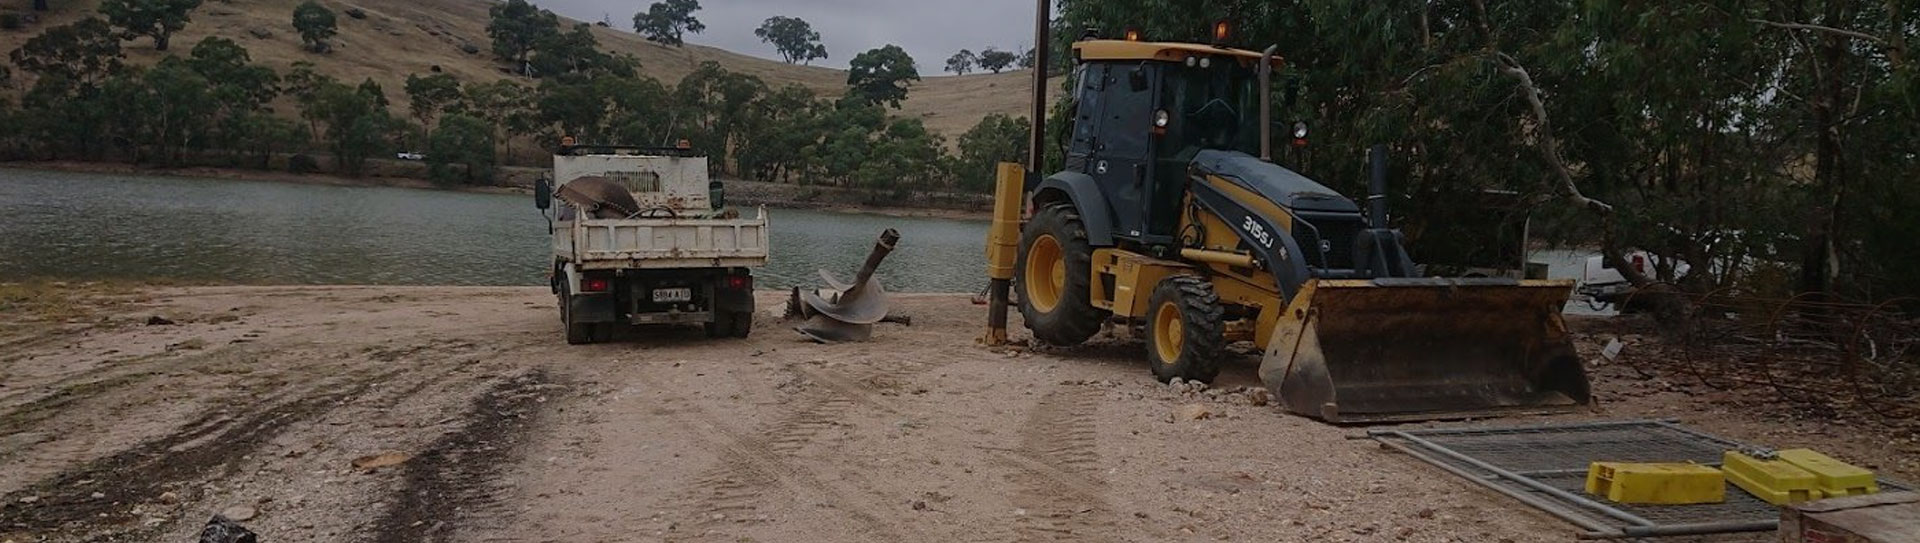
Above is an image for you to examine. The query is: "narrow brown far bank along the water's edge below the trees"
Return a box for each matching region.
[0,159,993,221]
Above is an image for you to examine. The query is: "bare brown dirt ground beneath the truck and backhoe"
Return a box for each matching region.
[0,288,1920,543]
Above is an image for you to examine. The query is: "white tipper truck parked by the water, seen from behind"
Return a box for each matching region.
[534,146,768,343]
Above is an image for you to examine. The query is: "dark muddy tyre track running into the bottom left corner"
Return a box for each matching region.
[0,370,401,539]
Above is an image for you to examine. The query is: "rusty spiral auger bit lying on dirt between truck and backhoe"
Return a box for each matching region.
[787,228,900,343]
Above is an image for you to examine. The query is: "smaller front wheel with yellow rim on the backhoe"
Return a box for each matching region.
[1146,274,1227,382]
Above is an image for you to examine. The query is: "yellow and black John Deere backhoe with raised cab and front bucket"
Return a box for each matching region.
[989,29,1590,422]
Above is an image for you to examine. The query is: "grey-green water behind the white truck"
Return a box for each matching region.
[0,169,987,292]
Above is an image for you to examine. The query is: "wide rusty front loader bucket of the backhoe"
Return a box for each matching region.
[1260,278,1590,424]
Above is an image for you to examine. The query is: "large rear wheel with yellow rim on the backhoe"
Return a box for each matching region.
[1014,203,1108,345]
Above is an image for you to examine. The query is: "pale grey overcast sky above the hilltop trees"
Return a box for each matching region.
[532,0,1033,75]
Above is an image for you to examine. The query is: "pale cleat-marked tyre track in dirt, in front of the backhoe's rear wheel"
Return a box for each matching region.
[1000,386,1112,541]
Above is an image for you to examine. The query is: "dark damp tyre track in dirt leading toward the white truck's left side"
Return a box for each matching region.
[369,370,559,543]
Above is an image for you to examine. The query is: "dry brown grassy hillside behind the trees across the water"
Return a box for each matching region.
[0,0,1052,140]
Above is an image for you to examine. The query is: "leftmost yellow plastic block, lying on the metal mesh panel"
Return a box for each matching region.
[1586,462,1726,505]
